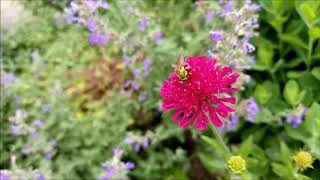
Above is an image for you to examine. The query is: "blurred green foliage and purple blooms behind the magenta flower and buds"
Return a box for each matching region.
[0,0,320,180]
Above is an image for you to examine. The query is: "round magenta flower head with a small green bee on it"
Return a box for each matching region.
[160,56,239,130]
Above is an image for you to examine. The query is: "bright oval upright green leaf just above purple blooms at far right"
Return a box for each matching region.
[283,80,300,105]
